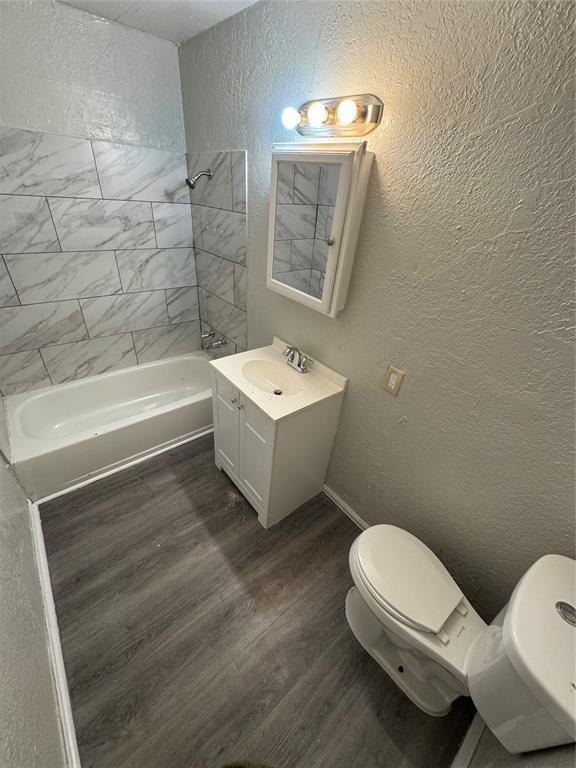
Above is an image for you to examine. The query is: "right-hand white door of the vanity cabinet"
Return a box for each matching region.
[239,395,276,512]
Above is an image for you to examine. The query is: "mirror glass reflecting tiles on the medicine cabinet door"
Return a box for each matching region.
[272,161,340,299]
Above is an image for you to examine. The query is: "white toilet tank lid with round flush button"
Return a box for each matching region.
[503,555,576,739]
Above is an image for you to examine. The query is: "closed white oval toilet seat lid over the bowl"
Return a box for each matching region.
[356,525,463,633]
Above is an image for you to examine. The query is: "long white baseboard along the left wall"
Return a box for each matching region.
[28,501,81,768]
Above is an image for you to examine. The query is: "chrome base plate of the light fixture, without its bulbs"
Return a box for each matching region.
[296,93,384,138]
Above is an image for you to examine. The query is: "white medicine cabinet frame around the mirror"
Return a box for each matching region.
[266,141,374,317]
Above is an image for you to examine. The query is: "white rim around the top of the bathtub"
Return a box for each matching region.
[6,352,211,464]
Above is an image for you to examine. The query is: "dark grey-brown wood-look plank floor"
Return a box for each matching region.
[40,437,472,768]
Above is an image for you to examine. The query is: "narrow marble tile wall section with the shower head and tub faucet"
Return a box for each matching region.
[188,151,246,354]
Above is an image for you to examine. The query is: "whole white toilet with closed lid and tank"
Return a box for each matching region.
[346,525,576,753]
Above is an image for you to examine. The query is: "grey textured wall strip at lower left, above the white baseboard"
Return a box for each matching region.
[0,456,65,768]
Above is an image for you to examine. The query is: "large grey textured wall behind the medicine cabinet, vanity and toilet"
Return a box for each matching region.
[180,0,574,618]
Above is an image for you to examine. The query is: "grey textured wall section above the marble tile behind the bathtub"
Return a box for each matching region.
[0,0,185,152]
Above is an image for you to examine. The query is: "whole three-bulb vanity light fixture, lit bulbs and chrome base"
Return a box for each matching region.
[282,93,384,138]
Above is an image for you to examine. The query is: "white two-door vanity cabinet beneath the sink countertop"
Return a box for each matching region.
[211,342,345,528]
